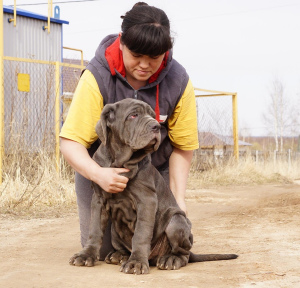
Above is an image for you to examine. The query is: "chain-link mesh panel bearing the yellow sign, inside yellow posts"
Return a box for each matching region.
[4,60,56,154]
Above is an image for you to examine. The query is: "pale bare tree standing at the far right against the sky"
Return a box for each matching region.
[263,77,291,151]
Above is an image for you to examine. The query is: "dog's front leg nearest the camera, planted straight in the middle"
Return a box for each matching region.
[120,194,157,274]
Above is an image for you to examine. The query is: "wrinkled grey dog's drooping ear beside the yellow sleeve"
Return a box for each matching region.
[96,104,115,145]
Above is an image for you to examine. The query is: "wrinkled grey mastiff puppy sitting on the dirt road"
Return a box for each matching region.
[70,99,237,274]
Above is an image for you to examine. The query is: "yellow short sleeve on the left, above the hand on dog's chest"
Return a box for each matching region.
[59,70,103,148]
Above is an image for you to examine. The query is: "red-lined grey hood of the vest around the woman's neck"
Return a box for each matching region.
[95,34,173,86]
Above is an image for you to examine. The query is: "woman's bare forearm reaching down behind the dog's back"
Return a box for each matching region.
[169,148,193,212]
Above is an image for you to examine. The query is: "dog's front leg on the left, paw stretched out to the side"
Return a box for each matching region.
[69,193,108,267]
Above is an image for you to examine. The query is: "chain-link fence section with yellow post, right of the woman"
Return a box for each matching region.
[193,88,239,170]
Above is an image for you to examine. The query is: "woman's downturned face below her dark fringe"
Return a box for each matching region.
[120,44,165,89]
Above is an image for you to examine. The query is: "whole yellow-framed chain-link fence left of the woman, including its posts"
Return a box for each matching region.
[1,57,86,181]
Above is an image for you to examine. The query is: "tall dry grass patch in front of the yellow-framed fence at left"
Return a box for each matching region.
[0,152,76,216]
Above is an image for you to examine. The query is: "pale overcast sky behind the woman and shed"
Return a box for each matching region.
[3,0,300,135]
